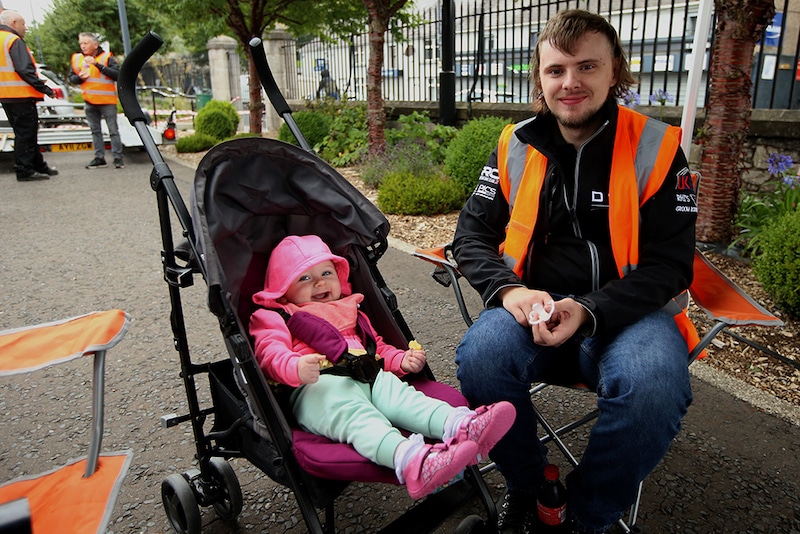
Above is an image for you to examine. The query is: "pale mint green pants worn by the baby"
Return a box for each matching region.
[290,371,454,469]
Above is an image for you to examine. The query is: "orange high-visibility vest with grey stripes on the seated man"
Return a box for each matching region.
[497,107,699,349]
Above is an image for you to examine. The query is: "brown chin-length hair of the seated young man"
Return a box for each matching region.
[531,9,637,113]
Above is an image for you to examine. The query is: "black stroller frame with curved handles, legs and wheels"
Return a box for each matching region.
[118,32,497,533]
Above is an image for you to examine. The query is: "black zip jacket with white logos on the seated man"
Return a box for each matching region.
[453,100,697,334]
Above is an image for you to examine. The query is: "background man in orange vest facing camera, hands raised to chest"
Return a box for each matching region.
[69,32,125,169]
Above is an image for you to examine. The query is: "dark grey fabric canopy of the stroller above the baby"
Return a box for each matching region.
[192,138,389,318]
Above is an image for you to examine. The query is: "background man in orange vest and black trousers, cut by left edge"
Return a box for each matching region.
[0,9,58,182]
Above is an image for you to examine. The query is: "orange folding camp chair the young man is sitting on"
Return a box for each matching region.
[413,244,783,532]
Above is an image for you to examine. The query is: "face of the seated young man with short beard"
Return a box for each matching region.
[539,32,617,131]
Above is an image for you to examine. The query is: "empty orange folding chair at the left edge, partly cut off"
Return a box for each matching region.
[0,310,133,534]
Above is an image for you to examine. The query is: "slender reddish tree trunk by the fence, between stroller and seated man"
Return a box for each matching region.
[367,11,388,154]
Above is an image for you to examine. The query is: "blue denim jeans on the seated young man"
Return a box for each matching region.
[456,308,692,530]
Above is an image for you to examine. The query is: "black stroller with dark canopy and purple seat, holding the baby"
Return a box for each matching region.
[118,33,496,533]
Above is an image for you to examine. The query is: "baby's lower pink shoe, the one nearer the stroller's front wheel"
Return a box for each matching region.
[403,441,478,500]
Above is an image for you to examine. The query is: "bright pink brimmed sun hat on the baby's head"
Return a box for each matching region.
[253,235,351,304]
